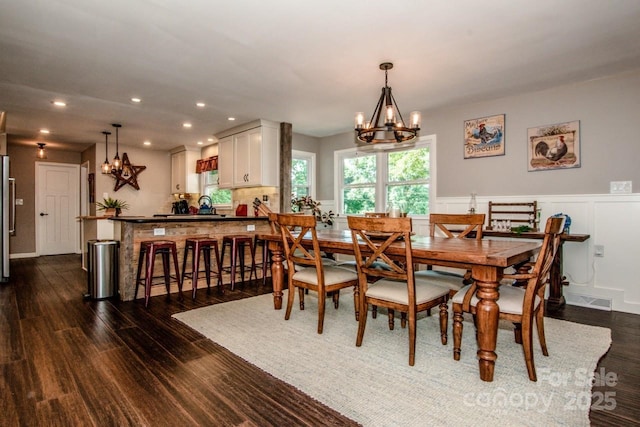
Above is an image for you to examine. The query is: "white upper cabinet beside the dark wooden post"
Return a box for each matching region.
[218,120,280,188]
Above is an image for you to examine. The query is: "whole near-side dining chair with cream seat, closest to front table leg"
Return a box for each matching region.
[347,216,449,366]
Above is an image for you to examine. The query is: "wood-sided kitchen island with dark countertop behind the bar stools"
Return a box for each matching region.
[111,215,270,301]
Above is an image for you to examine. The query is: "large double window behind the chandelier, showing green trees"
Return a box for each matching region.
[336,138,433,215]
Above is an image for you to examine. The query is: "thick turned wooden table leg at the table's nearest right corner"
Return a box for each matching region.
[472,266,502,381]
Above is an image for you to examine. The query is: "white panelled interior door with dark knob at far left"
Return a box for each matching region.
[36,162,80,255]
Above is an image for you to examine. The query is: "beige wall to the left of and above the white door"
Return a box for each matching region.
[7,144,81,254]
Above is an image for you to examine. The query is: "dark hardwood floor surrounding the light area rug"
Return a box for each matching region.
[0,255,640,426]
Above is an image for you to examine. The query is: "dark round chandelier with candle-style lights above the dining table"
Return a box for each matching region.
[355,62,420,144]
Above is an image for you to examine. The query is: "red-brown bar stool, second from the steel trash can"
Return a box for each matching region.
[182,237,224,299]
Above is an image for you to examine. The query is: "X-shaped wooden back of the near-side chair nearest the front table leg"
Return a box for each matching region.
[347,216,415,286]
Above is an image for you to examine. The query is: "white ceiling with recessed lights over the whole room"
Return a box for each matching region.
[0,0,640,150]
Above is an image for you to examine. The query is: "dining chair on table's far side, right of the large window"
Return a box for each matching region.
[415,213,485,297]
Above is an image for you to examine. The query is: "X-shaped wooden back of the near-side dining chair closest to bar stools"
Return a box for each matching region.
[276,214,322,272]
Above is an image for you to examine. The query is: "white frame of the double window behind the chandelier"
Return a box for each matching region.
[333,135,437,218]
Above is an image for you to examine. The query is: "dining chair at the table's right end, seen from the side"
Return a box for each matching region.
[452,217,565,381]
